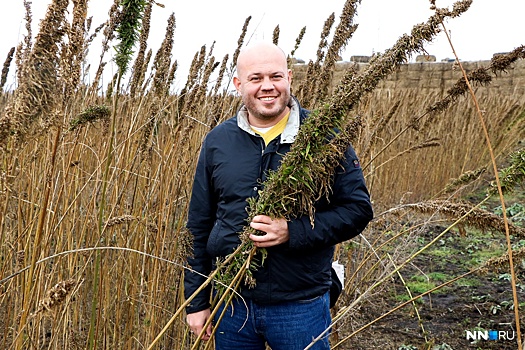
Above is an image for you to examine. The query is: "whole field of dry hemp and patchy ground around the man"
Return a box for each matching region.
[0,0,525,349]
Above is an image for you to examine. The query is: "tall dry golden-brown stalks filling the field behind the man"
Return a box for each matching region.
[0,0,525,349]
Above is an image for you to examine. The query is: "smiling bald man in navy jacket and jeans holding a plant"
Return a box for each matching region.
[185,43,373,350]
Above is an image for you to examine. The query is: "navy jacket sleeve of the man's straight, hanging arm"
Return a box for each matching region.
[184,140,216,313]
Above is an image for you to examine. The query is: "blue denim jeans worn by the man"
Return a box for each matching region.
[215,293,331,350]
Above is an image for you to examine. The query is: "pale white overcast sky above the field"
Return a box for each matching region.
[0,0,525,87]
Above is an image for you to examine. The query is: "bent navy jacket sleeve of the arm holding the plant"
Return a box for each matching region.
[288,147,373,250]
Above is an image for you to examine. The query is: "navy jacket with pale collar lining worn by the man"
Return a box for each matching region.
[184,99,373,313]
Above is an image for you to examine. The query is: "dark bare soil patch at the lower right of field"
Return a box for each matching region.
[335,226,525,350]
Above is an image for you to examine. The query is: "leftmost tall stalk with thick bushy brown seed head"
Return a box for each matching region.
[0,0,68,349]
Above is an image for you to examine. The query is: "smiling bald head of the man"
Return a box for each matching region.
[233,43,292,127]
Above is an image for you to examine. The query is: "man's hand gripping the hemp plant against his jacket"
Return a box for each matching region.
[250,215,290,248]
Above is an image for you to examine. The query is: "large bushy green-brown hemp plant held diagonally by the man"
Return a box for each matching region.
[211,0,472,308]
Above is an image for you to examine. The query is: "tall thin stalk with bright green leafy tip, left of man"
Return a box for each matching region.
[87,0,147,349]
